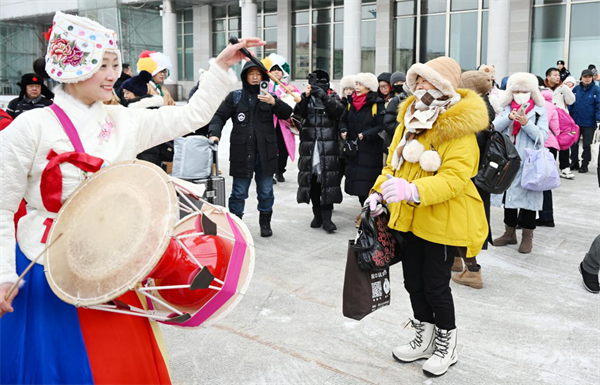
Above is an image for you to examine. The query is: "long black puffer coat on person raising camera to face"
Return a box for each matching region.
[294,92,344,205]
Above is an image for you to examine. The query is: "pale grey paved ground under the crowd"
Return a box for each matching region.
[162,124,600,385]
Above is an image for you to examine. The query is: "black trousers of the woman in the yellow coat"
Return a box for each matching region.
[400,232,456,330]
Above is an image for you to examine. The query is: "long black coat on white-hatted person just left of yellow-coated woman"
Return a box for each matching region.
[340,92,385,197]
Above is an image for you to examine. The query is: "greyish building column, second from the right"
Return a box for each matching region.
[375,0,394,75]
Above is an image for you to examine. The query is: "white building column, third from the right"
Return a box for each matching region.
[344,0,362,76]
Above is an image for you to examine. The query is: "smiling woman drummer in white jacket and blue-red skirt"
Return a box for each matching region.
[0,12,264,384]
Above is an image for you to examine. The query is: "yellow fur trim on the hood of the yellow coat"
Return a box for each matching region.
[397,89,489,146]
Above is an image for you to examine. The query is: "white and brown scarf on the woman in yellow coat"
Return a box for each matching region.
[392,89,460,170]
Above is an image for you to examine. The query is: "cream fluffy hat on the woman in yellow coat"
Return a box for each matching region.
[406,56,461,96]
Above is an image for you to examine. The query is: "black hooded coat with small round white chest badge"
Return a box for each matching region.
[208,61,293,178]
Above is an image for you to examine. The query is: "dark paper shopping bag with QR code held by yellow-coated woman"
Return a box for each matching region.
[342,240,391,321]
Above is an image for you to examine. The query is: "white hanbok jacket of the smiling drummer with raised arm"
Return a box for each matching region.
[0,65,231,284]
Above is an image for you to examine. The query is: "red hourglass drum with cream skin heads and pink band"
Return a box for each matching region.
[44,160,254,327]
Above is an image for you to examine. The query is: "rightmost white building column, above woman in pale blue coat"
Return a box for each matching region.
[484,0,508,79]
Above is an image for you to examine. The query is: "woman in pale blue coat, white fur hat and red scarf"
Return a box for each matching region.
[492,72,548,254]
